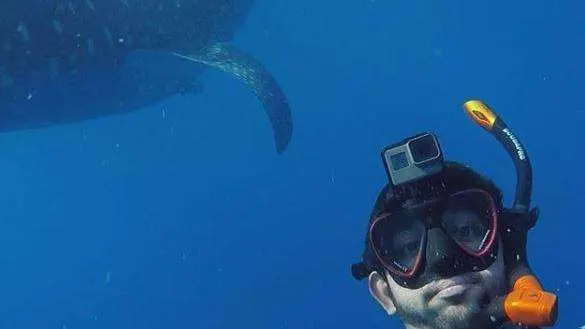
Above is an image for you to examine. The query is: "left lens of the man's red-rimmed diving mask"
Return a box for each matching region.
[371,212,426,276]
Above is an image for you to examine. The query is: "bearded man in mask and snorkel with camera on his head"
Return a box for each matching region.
[351,100,557,329]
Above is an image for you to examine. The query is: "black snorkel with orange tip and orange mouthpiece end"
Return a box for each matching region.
[463,100,558,328]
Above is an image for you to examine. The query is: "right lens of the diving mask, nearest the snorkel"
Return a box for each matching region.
[441,190,496,255]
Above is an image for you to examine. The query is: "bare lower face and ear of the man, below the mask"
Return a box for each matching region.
[369,238,505,329]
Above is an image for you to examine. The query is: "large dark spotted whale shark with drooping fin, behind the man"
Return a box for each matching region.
[0,0,293,153]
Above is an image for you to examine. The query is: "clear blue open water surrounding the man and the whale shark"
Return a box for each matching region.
[0,0,585,329]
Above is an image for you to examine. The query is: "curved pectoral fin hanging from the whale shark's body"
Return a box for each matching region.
[174,43,292,153]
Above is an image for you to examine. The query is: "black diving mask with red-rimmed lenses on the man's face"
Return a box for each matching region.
[368,189,497,286]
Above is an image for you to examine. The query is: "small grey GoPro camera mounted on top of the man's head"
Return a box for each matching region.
[382,132,444,186]
